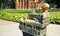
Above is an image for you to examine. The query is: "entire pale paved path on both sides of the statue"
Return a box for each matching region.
[0,20,60,36]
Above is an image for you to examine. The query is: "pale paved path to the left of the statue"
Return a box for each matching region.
[0,20,23,36]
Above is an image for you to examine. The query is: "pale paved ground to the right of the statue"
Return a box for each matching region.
[47,24,60,36]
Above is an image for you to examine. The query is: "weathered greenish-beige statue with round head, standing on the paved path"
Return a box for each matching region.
[19,3,50,36]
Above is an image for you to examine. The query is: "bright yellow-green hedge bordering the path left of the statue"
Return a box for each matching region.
[0,12,27,22]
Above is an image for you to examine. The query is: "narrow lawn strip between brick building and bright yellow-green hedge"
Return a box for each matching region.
[0,9,32,13]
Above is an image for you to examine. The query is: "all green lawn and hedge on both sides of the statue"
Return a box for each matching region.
[0,9,60,24]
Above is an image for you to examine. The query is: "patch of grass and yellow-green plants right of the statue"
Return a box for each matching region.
[50,12,60,24]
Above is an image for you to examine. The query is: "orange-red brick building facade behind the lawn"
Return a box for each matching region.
[15,0,40,9]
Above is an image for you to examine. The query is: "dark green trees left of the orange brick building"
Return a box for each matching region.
[0,0,15,9]
